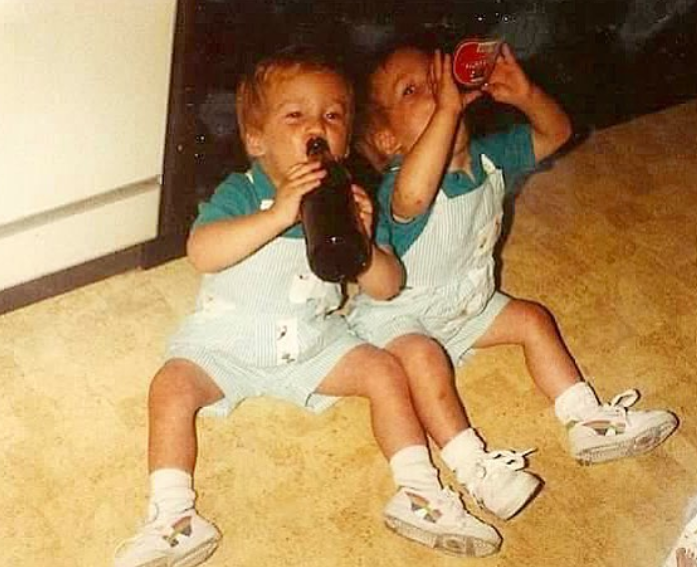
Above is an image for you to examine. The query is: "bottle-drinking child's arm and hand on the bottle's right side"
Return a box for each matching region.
[353,185,404,299]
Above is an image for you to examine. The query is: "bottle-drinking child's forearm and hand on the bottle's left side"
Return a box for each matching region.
[187,162,326,273]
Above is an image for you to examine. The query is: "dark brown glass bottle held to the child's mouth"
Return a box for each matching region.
[300,138,372,282]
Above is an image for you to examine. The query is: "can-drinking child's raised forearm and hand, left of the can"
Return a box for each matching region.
[392,51,481,220]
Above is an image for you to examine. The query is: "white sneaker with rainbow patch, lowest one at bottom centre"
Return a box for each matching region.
[384,488,501,557]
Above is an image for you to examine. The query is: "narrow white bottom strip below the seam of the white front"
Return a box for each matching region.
[0,179,161,290]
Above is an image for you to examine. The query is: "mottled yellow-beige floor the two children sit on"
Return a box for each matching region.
[0,102,697,567]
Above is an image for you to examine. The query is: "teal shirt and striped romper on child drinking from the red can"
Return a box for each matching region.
[349,125,535,364]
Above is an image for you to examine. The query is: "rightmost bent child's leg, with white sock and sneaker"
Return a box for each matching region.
[474,299,677,464]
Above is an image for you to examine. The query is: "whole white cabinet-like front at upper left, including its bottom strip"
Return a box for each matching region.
[0,0,176,289]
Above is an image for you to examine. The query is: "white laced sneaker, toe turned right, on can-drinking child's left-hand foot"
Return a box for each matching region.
[463,449,542,520]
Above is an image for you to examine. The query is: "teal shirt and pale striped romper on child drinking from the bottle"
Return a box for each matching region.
[166,163,364,415]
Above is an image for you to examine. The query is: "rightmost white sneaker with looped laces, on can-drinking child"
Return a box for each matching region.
[567,390,678,465]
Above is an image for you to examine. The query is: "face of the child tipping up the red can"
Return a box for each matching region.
[371,48,436,154]
